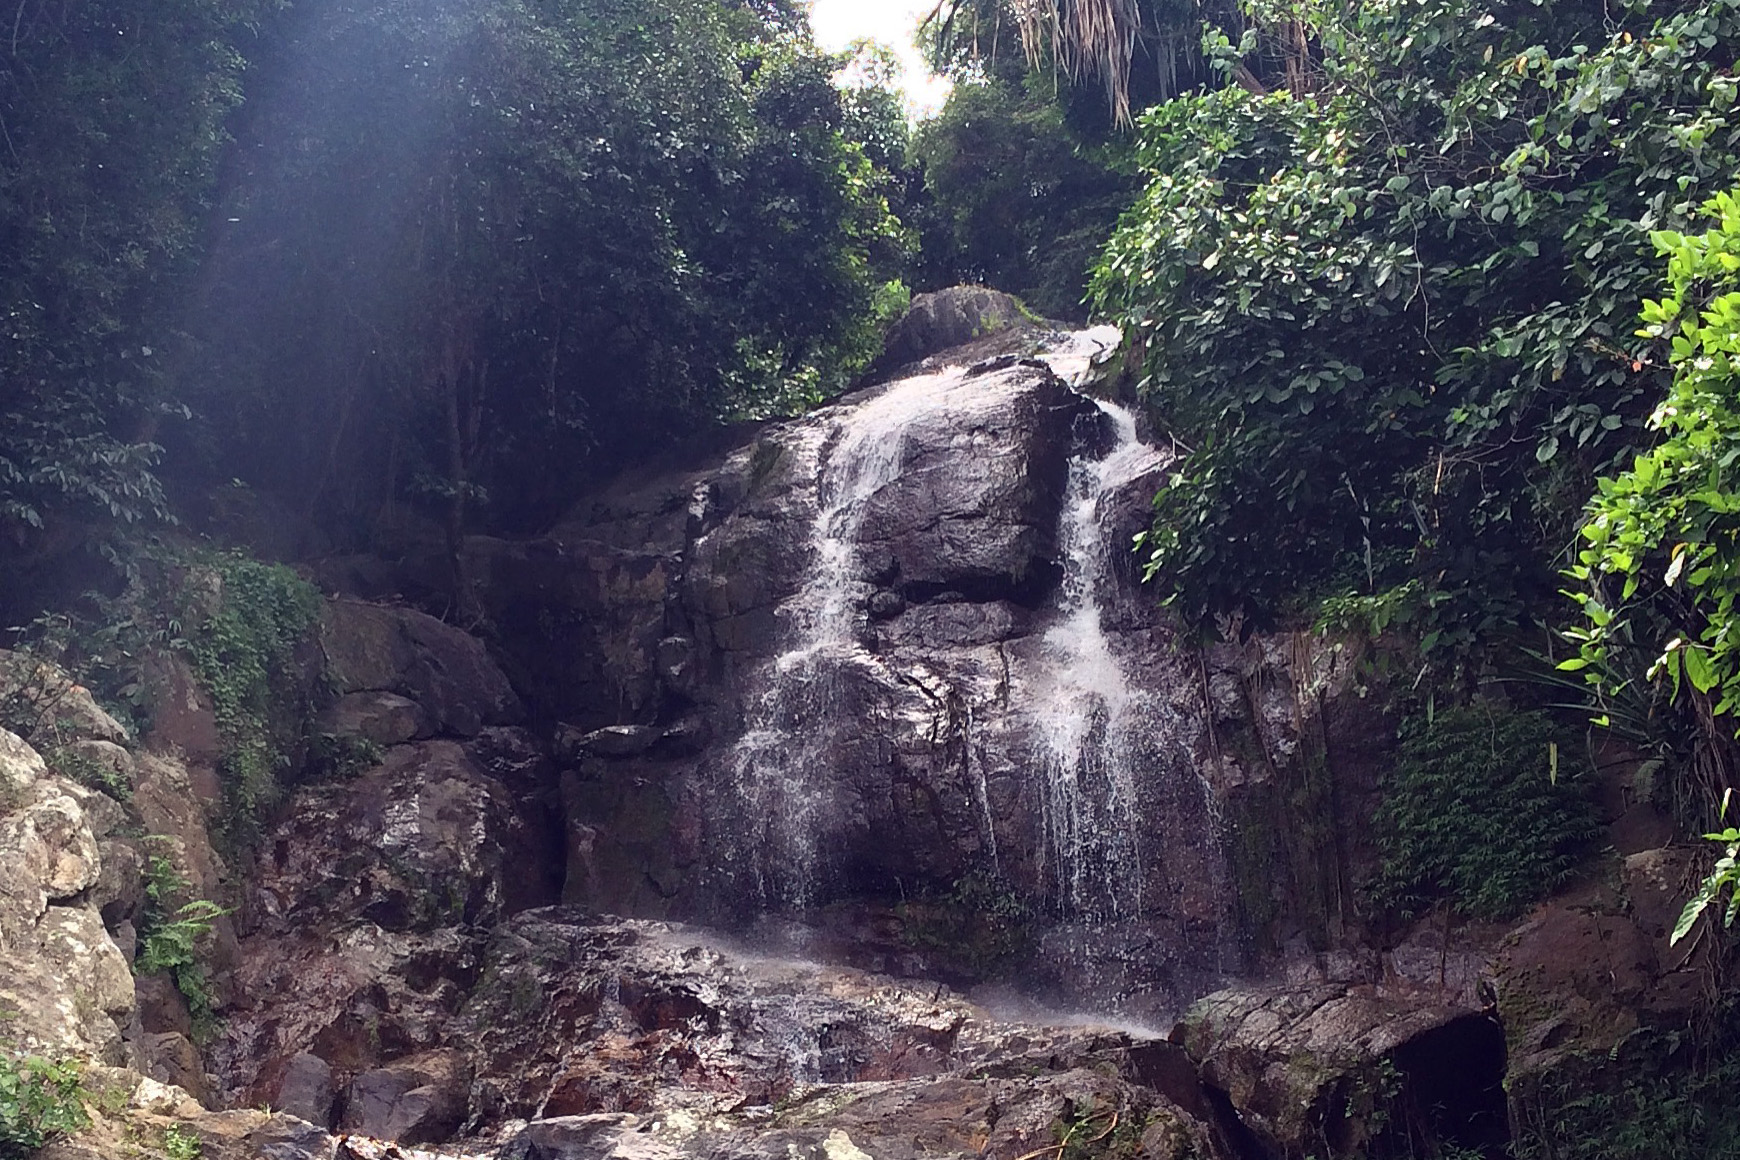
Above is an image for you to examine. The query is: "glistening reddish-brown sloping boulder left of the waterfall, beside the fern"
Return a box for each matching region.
[212,729,562,1106]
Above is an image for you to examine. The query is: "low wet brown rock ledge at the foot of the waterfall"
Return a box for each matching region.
[220,908,1237,1160]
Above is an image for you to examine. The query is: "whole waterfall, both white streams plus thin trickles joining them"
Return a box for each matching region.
[727,327,1181,953]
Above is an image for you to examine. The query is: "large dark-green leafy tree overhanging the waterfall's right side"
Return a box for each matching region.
[1093,0,1740,656]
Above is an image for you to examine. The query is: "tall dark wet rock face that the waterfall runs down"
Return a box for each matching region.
[445,349,1228,1007]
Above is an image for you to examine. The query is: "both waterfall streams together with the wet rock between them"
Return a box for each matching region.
[719,321,1218,1005]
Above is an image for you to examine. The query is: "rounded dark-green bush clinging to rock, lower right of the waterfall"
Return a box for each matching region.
[1371,703,1599,918]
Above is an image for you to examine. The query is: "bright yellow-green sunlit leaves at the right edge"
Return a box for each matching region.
[1559,193,1740,717]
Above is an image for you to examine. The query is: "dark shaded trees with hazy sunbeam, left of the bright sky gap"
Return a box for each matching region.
[0,0,910,612]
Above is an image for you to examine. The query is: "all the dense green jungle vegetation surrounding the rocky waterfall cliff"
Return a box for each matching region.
[10,0,1740,1155]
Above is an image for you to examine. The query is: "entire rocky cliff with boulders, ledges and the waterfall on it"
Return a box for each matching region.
[0,292,1705,1160]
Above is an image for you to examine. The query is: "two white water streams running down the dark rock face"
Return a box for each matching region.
[731,327,1164,920]
